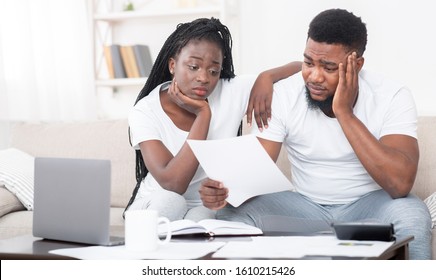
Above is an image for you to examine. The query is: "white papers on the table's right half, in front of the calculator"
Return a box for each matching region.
[212,235,394,259]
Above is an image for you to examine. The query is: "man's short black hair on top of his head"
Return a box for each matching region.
[307,9,367,56]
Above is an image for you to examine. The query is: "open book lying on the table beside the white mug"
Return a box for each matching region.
[158,219,263,236]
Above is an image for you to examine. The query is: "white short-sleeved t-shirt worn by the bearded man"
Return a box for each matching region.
[253,70,417,204]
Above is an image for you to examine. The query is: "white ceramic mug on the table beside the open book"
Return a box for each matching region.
[125,210,171,252]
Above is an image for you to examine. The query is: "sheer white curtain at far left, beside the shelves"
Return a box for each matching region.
[0,0,97,121]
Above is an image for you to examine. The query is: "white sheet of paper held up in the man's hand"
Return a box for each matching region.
[188,135,293,207]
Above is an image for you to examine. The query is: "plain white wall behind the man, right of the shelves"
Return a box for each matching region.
[235,0,436,115]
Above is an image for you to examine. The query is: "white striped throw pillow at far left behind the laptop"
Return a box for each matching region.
[0,148,34,210]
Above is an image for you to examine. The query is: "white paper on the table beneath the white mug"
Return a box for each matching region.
[49,241,225,260]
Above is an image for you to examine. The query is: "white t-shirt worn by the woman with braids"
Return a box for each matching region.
[129,75,256,208]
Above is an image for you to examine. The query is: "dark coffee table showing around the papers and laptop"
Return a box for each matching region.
[0,235,413,260]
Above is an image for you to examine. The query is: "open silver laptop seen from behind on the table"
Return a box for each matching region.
[33,157,124,246]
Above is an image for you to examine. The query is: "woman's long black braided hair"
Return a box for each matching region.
[126,18,235,209]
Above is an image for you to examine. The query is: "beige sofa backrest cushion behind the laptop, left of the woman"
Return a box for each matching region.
[11,119,135,207]
